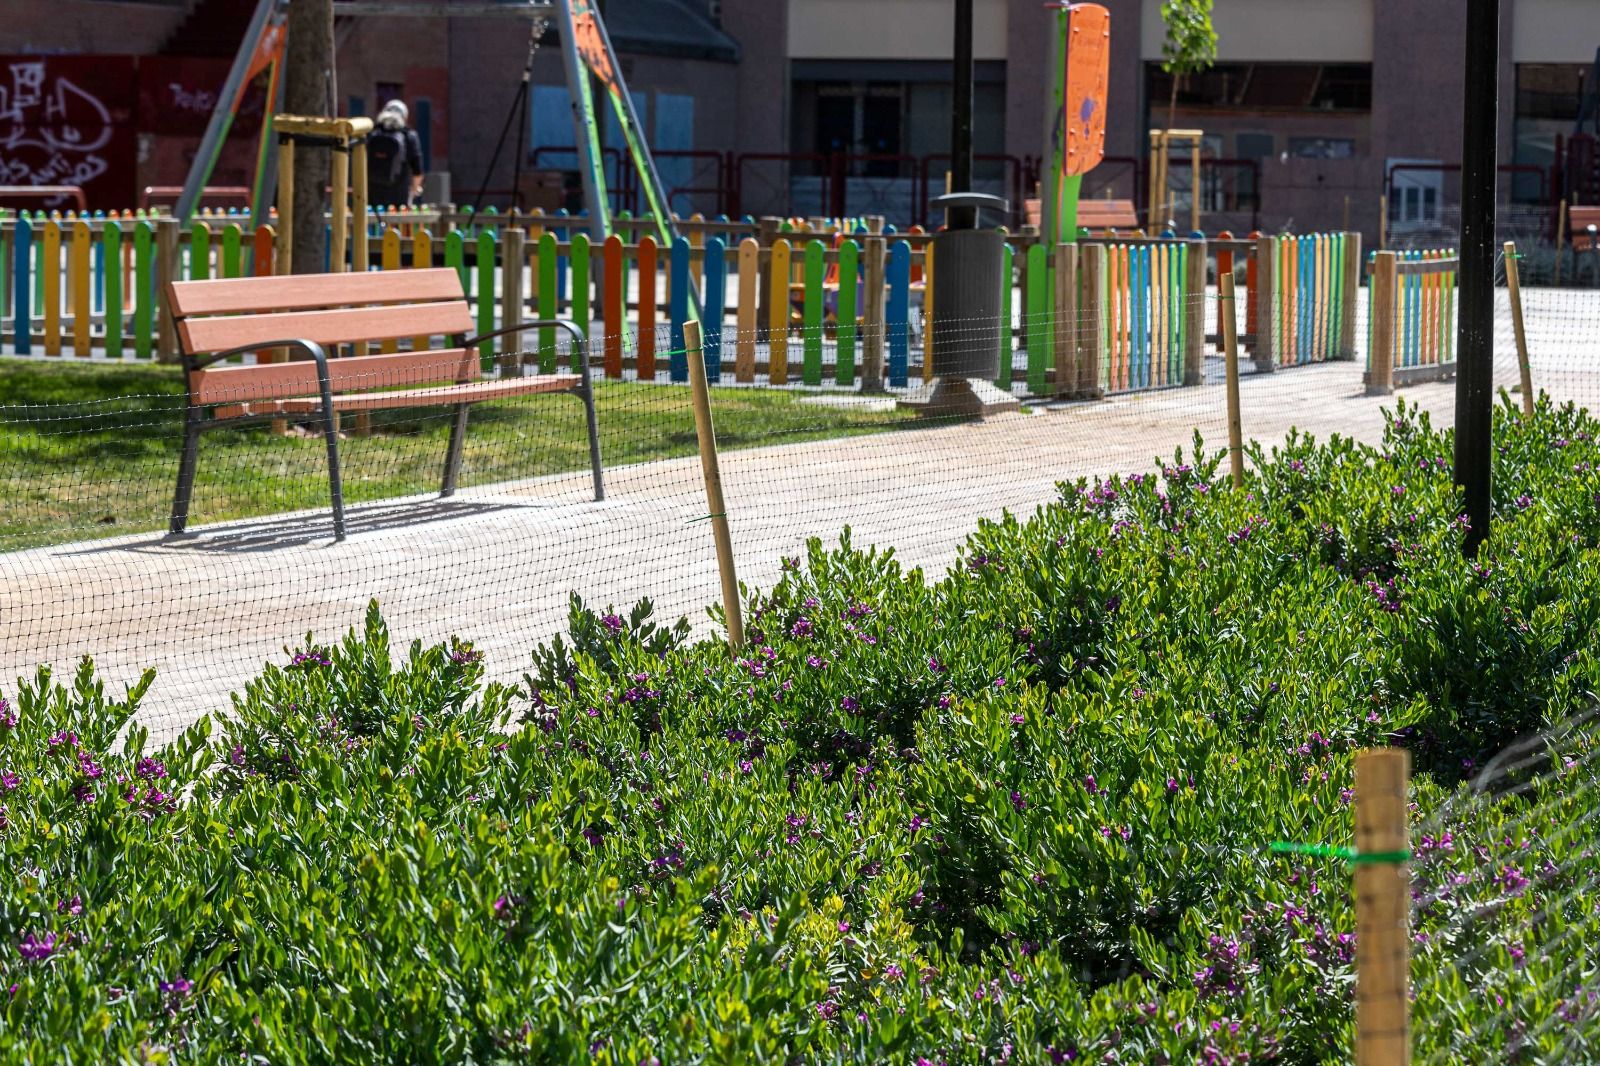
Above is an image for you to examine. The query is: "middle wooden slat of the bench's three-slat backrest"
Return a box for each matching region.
[178,300,472,354]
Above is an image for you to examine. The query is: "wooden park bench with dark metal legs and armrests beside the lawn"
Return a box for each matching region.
[166,269,605,539]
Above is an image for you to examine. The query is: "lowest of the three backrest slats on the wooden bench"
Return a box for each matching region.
[189,347,480,403]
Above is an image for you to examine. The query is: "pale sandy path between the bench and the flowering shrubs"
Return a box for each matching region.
[0,352,1478,735]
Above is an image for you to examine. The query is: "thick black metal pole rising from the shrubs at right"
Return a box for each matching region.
[1456,0,1499,555]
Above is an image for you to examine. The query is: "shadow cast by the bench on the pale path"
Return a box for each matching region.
[62,499,539,555]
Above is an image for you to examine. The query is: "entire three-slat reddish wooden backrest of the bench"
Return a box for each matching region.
[166,267,480,403]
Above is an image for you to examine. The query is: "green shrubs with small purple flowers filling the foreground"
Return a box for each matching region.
[0,393,1600,1066]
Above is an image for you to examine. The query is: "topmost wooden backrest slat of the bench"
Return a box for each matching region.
[168,267,464,317]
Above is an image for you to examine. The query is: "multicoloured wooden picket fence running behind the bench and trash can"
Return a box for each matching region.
[0,211,1354,395]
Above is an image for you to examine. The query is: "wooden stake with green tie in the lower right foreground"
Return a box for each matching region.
[1355,747,1411,1066]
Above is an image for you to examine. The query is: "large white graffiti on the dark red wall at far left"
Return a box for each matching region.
[0,56,134,208]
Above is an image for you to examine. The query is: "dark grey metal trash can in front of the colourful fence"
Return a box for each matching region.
[930,192,1006,381]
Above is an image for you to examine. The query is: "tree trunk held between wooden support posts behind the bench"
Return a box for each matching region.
[278,0,334,274]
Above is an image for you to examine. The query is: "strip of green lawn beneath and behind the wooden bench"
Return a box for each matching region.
[0,359,909,551]
